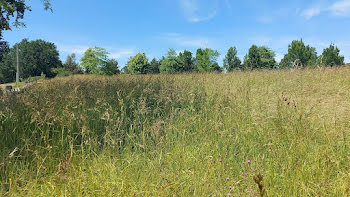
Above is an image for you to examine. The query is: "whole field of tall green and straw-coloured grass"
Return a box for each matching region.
[0,67,350,196]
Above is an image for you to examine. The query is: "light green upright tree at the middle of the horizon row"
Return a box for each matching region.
[196,48,221,72]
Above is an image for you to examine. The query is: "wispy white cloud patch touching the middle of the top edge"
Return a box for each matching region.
[179,0,217,23]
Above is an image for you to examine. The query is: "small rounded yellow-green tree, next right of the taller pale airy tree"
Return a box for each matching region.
[125,53,149,74]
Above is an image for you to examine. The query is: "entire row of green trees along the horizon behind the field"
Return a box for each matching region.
[0,39,344,83]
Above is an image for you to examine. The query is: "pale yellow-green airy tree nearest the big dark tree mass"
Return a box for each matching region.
[80,47,120,75]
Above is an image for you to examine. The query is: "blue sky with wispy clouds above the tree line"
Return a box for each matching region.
[4,0,350,67]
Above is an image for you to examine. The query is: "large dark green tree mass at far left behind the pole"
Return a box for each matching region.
[0,39,62,83]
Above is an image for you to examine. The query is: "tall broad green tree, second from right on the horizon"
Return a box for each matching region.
[280,39,317,68]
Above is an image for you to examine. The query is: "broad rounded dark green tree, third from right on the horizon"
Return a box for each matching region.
[243,45,277,70]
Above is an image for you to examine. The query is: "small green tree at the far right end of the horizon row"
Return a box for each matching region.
[319,44,344,66]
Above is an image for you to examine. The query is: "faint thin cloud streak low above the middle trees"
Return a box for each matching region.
[159,33,209,48]
